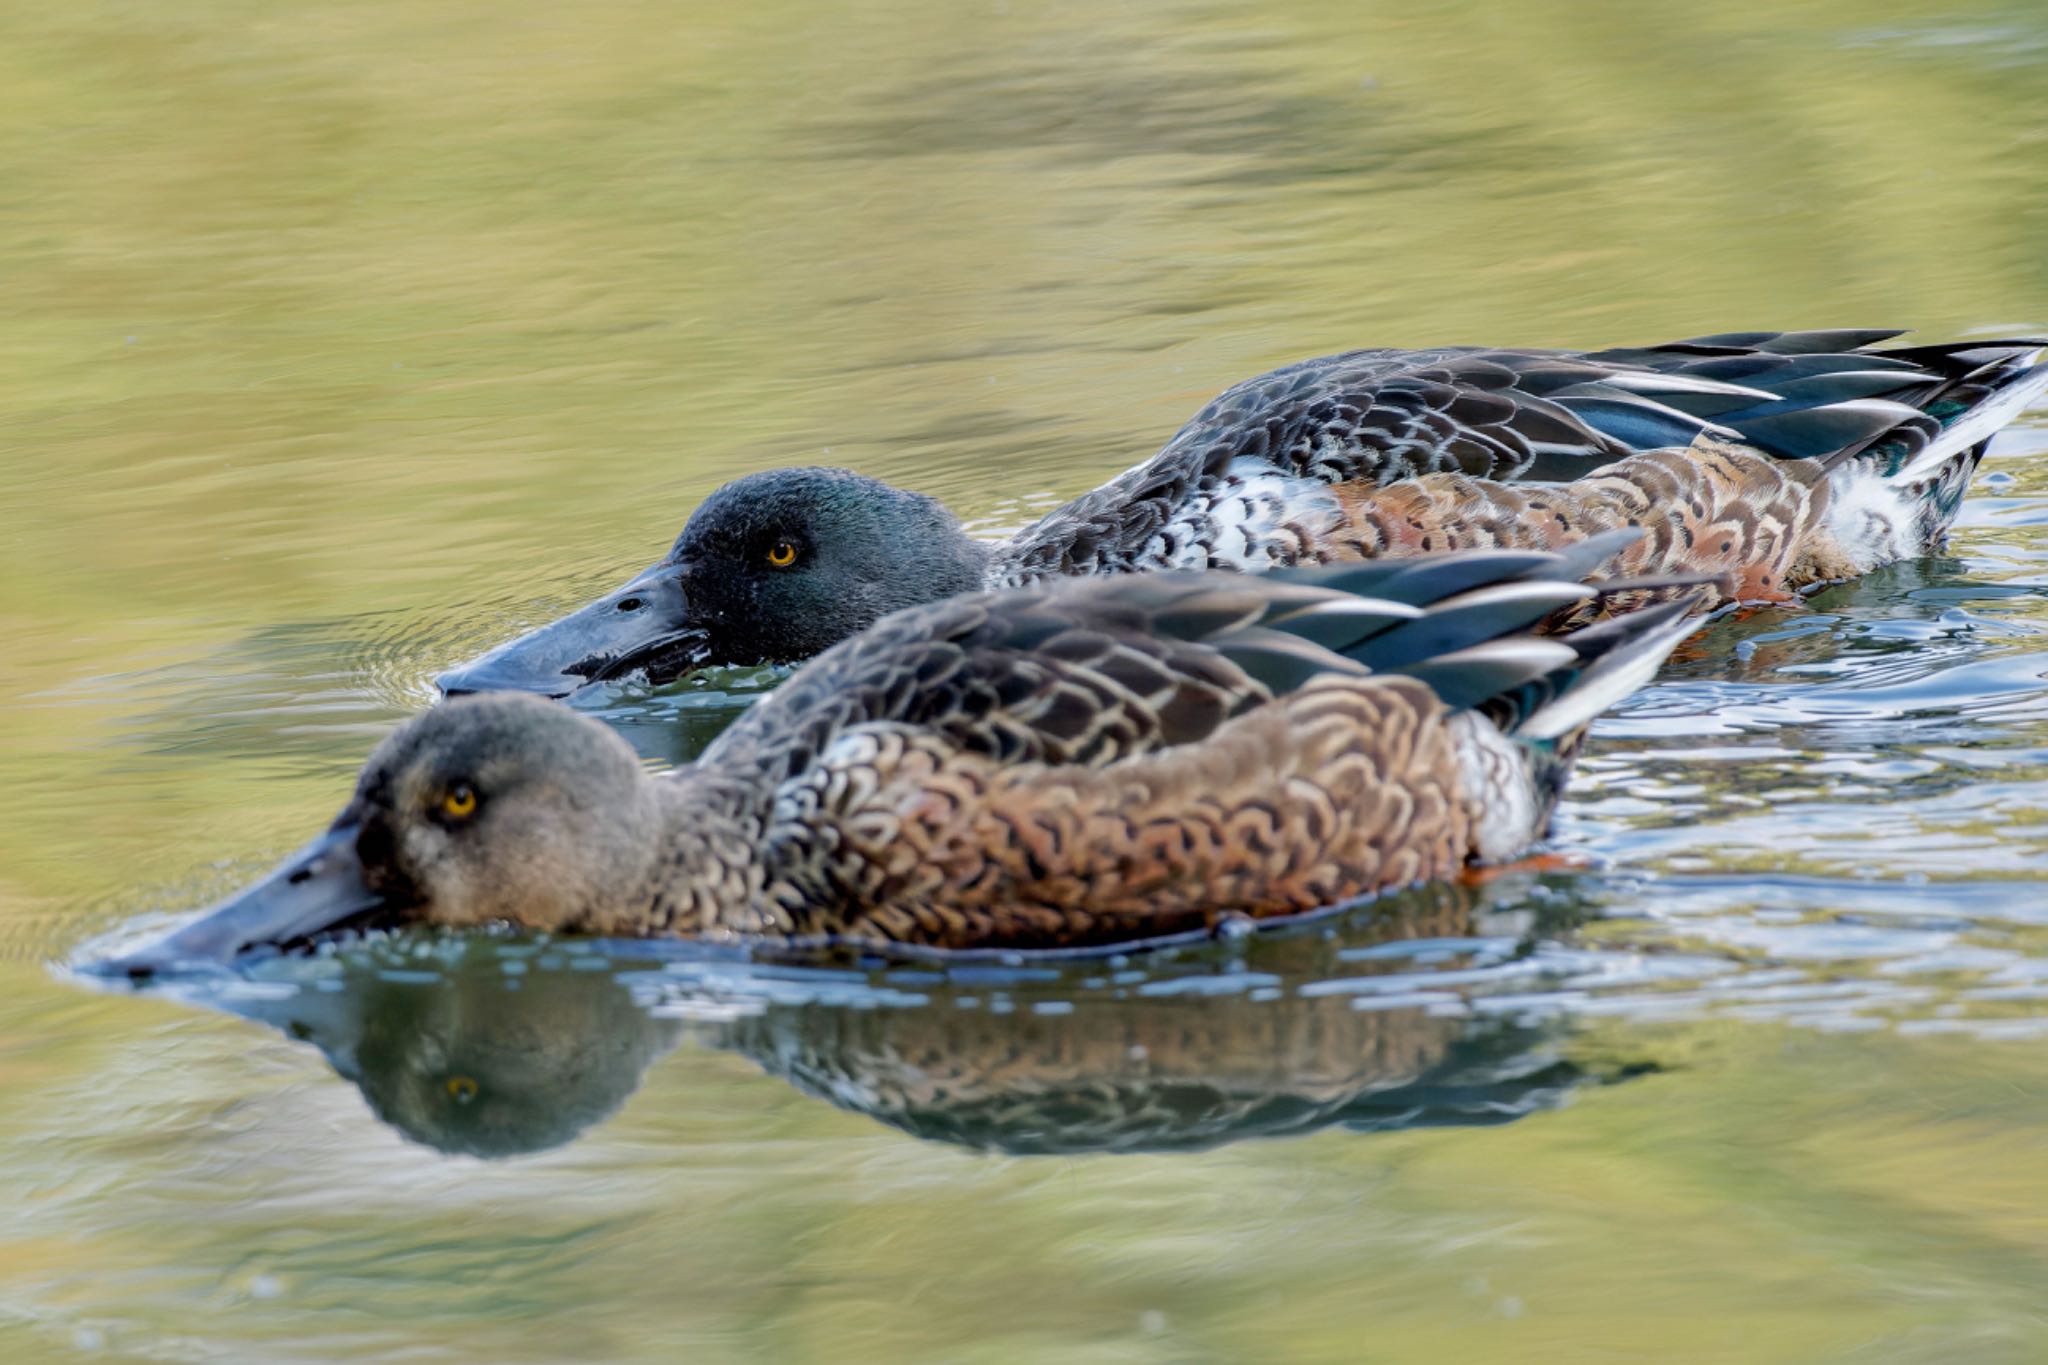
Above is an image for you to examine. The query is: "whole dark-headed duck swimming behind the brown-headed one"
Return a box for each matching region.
[436,329,2048,698]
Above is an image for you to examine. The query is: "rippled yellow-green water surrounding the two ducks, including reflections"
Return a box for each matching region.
[0,0,2048,1361]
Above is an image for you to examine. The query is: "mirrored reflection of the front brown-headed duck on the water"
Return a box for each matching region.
[209,878,1638,1156]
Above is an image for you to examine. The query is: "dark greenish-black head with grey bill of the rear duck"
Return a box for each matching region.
[434,469,987,696]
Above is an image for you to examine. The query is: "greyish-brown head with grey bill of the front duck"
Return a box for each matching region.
[96,694,666,976]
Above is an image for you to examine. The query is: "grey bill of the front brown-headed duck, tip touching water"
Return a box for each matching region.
[90,825,406,978]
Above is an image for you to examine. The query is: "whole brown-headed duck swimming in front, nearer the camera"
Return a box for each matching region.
[116,530,1700,978]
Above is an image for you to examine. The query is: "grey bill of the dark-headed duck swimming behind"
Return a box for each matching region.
[434,565,711,698]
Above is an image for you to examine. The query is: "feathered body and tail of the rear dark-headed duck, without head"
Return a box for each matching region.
[989,329,2038,585]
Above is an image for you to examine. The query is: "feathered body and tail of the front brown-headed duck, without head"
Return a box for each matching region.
[700,544,1683,948]
